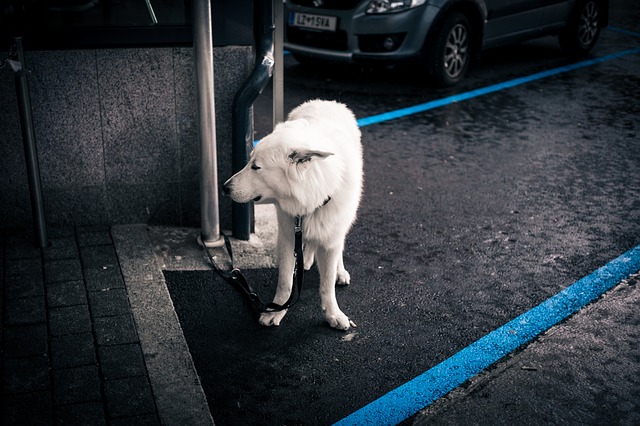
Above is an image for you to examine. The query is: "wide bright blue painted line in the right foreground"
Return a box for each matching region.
[336,246,640,426]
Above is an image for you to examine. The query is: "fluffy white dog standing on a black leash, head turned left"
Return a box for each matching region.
[224,100,363,330]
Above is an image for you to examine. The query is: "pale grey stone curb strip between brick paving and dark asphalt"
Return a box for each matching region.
[111,224,214,425]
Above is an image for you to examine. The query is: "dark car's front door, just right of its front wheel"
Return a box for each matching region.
[484,0,548,47]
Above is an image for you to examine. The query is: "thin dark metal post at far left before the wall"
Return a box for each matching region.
[14,37,49,248]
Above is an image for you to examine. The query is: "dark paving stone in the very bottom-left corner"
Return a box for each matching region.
[2,391,53,426]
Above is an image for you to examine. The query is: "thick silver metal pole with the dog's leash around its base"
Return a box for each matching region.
[193,0,224,247]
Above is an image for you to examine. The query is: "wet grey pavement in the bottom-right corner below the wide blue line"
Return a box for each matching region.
[415,275,640,426]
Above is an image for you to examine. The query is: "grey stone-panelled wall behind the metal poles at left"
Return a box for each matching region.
[0,46,253,228]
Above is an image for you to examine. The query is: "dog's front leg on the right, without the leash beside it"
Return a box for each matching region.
[316,247,353,330]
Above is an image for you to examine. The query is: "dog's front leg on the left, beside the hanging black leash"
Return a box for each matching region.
[259,212,295,327]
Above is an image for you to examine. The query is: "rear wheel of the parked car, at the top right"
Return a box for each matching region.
[558,0,602,57]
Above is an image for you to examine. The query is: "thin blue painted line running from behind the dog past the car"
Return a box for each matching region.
[358,48,640,127]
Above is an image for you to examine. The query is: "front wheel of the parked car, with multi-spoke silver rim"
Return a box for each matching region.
[426,12,473,87]
